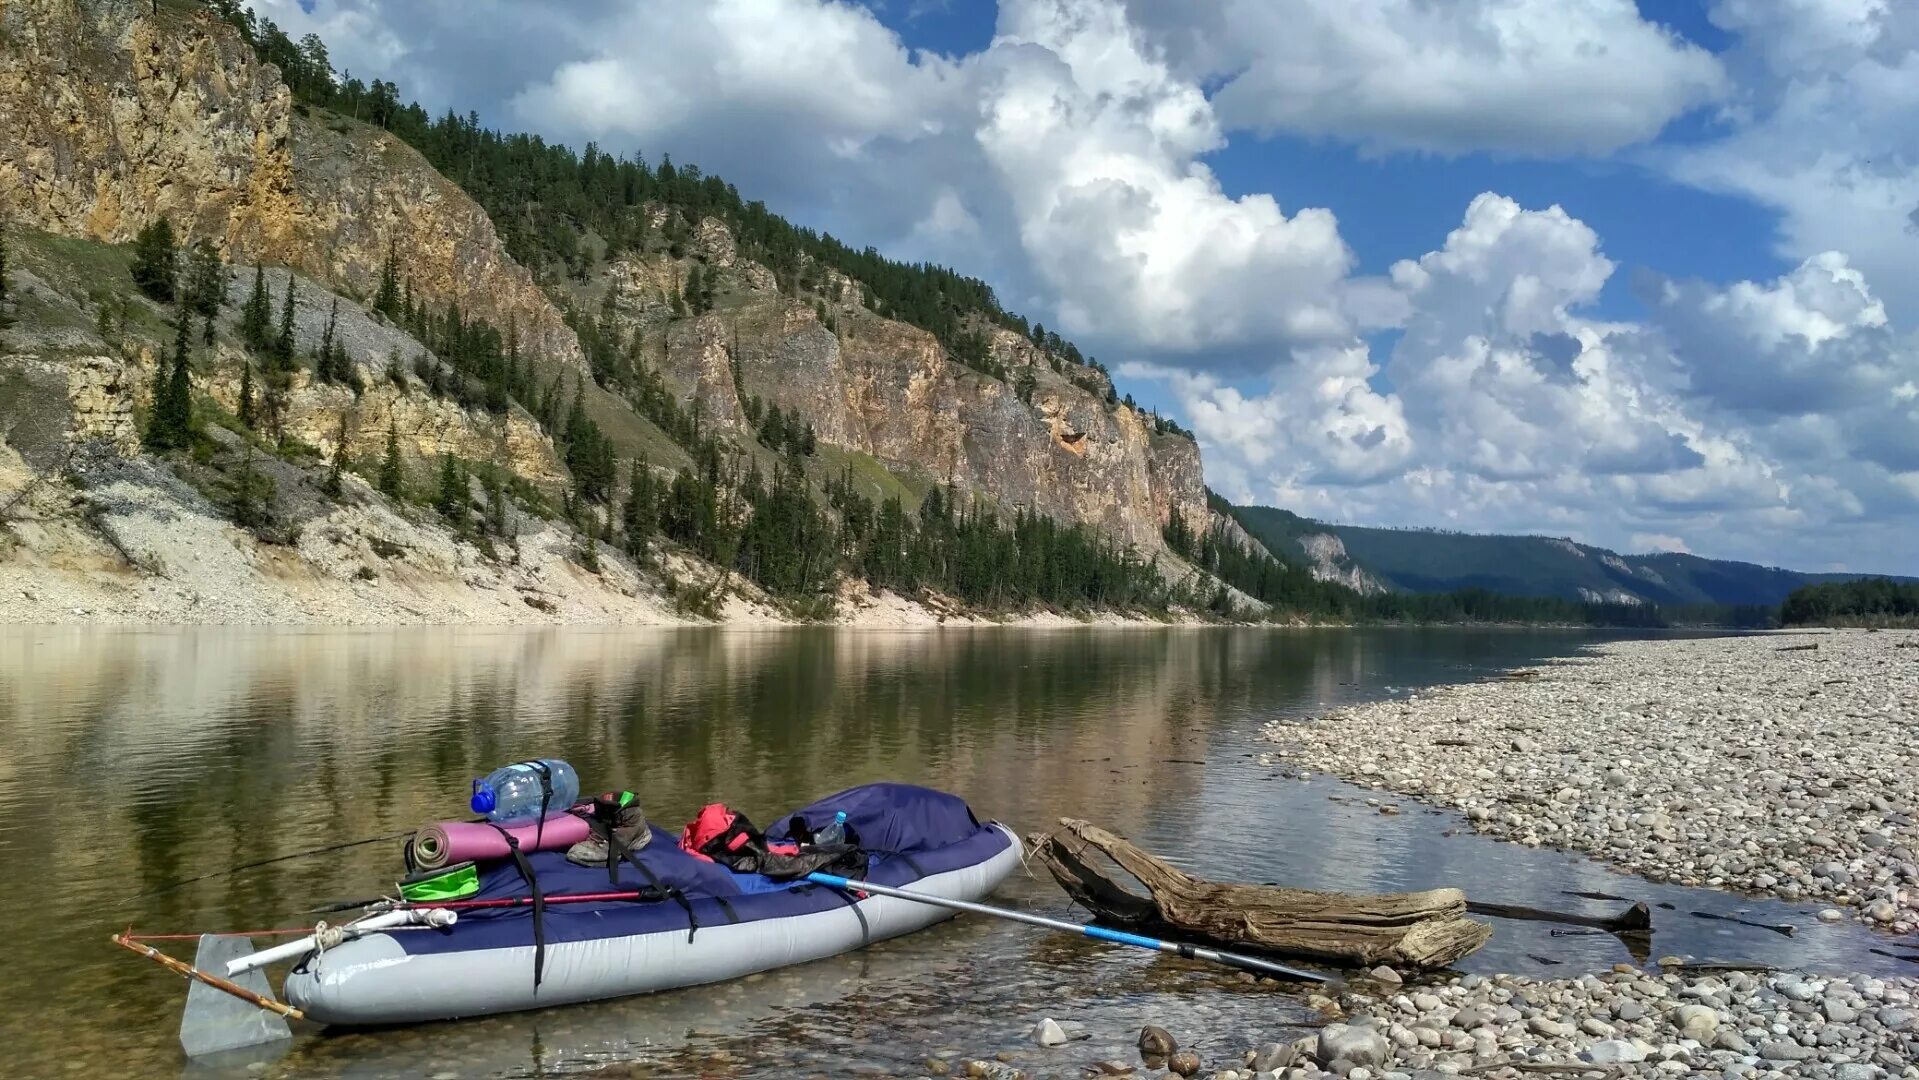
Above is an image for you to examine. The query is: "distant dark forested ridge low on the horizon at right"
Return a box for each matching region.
[1232,506,1903,606]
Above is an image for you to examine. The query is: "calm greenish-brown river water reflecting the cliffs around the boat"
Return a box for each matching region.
[0,629,1900,1076]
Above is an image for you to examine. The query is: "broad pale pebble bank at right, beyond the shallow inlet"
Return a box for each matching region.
[1263,631,1919,932]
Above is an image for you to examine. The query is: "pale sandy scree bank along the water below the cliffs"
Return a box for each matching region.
[0,445,1205,629]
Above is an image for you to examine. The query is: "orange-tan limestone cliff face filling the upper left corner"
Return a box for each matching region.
[0,0,580,363]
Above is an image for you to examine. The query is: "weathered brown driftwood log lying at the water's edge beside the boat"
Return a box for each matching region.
[1032,817,1493,969]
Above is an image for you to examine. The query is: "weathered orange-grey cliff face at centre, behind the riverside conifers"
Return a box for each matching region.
[608,238,1205,549]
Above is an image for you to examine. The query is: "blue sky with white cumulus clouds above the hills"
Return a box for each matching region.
[259,0,1919,572]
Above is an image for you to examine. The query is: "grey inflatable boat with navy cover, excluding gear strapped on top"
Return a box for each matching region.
[284,785,1021,1024]
